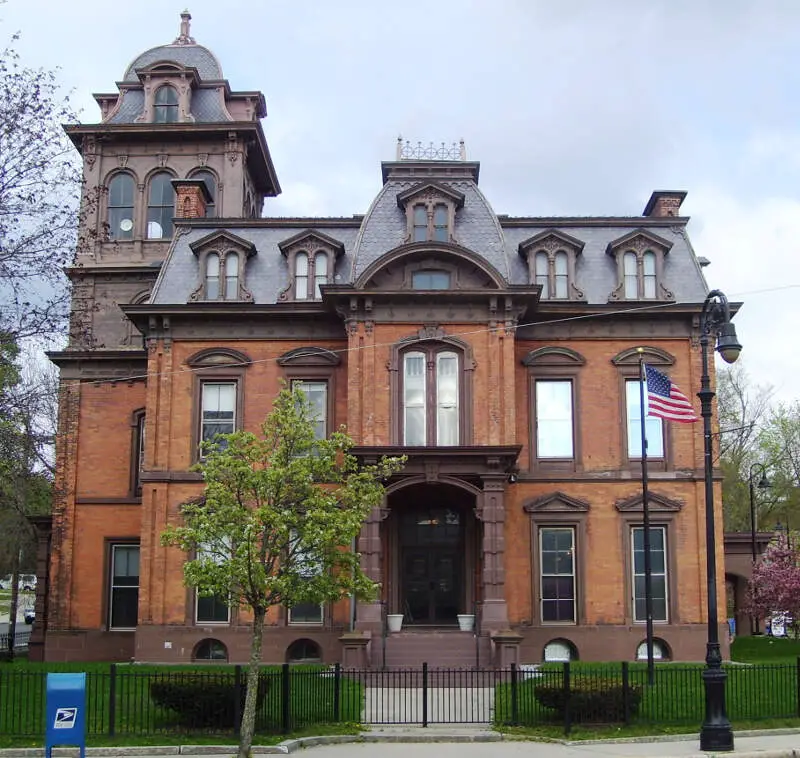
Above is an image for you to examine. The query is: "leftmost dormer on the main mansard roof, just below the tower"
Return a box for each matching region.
[190,232,255,302]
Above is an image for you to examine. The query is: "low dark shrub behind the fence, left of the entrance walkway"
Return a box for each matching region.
[150,674,269,729]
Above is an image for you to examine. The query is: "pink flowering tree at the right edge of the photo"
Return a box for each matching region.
[746,531,800,621]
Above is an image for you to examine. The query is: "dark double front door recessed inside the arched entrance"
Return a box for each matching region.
[400,507,465,624]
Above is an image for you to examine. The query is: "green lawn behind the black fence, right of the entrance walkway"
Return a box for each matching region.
[495,663,800,729]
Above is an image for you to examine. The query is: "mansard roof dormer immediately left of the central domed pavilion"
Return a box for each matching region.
[278,230,344,301]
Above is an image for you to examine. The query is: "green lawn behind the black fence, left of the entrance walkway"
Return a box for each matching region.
[0,662,363,745]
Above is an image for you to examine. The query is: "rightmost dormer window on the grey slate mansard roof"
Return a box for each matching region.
[607,230,674,300]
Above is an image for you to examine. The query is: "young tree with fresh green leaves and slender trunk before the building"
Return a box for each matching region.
[162,389,404,758]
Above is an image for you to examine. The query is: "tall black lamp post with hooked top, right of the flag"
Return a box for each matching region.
[697,290,742,750]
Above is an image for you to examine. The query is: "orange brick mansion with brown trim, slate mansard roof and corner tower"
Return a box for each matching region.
[34,14,724,665]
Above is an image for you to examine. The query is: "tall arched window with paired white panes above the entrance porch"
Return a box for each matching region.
[402,346,461,446]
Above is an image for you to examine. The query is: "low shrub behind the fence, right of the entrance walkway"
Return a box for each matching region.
[534,681,642,724]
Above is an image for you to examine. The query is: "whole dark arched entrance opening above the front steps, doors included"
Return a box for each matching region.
[384,484,479,626]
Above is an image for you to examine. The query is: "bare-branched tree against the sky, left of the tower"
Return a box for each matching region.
[0,36,92,344]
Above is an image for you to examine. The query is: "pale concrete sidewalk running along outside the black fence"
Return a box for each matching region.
[0,726,800,758]
